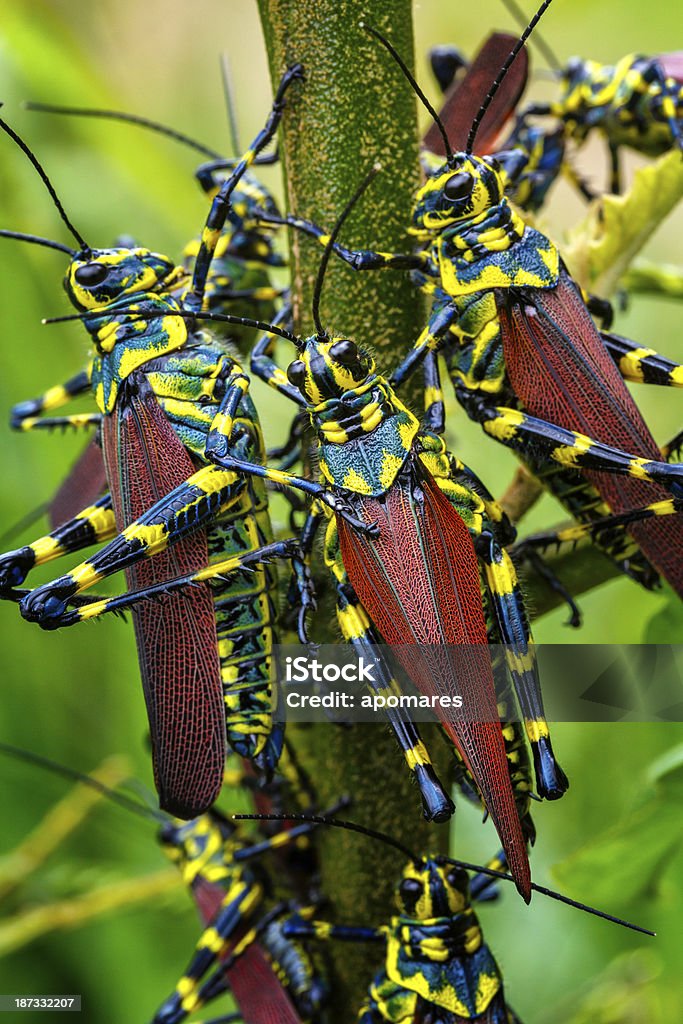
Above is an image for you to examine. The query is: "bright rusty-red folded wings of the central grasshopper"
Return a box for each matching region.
[338,466,530,901]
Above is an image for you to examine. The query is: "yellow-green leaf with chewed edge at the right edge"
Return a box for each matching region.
[563,150,683,295]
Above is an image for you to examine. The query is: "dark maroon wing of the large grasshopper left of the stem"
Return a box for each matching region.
[102,372,225,818]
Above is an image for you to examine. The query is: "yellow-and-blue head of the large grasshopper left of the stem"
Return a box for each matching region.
[63,249,176,311]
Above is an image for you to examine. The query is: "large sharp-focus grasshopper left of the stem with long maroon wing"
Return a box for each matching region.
[0,66,310,817]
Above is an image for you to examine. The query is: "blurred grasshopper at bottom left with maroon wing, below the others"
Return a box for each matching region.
[0,743,331,1024]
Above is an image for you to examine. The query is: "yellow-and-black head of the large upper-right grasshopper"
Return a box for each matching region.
[411,153,504,238]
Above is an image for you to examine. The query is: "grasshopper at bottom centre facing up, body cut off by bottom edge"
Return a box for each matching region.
[234,814,653,1024]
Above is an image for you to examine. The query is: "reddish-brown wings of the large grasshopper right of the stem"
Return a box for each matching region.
[497,271,683,595]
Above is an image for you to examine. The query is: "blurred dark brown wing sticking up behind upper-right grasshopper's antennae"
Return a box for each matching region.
[422,32,528,154]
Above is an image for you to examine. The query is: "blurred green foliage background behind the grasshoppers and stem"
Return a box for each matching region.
[0,0,683,1024]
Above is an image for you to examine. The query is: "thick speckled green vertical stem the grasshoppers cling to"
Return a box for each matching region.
[259,0,449,1022]
